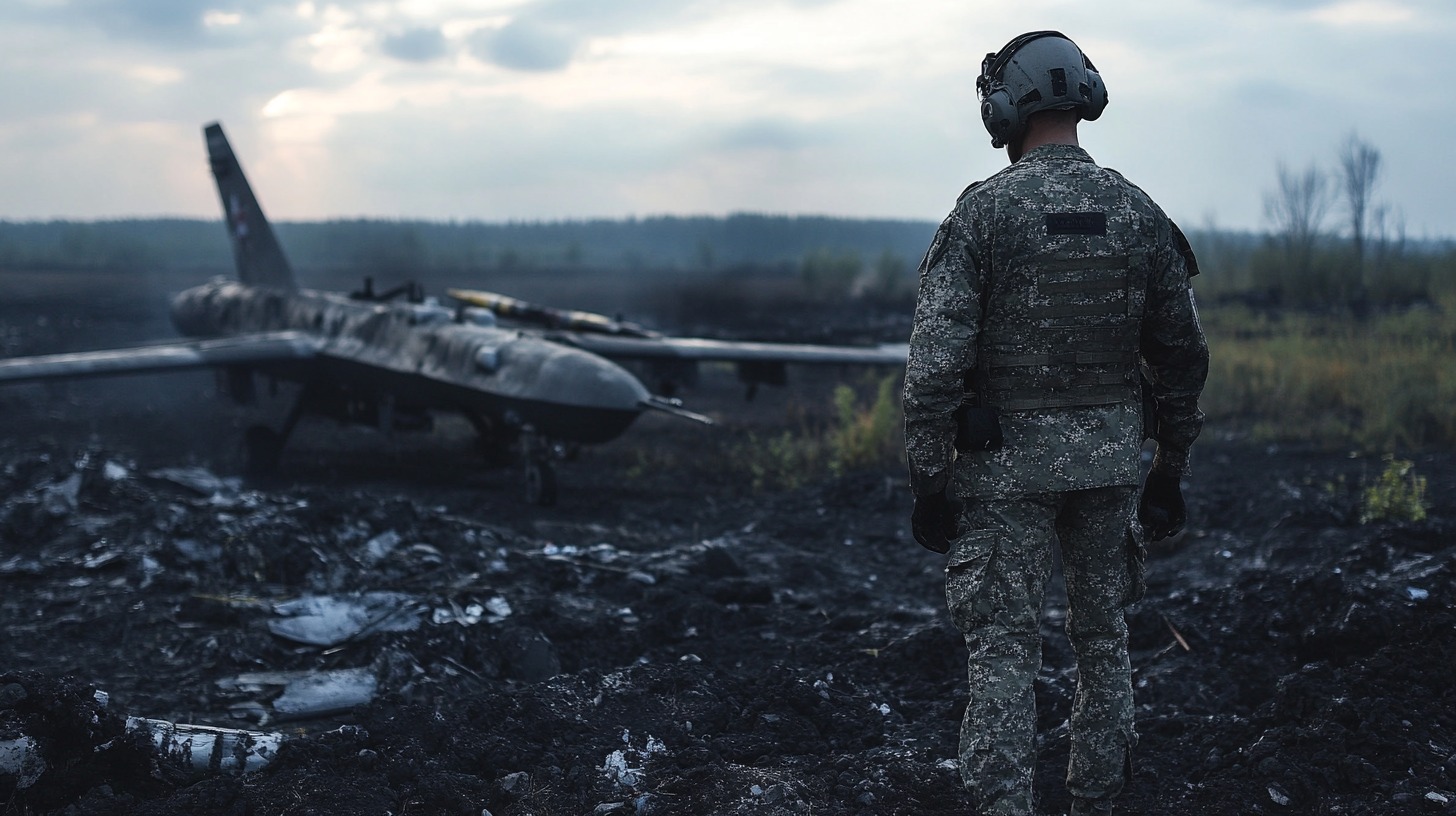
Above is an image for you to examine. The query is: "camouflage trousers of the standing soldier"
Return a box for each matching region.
[945,487,1143,816]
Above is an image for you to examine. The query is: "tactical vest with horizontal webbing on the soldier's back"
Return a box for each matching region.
[974,242,1149,411]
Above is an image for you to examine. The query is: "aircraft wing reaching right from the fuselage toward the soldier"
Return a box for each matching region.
[547,334,910,366]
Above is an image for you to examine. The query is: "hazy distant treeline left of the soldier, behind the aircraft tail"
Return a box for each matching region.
[0,214,935,274]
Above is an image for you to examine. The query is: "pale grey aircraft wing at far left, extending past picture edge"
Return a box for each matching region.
[0,332,319,383]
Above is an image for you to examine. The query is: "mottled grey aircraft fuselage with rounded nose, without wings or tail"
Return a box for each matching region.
[172,280,649,444]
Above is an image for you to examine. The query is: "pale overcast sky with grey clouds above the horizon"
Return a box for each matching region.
[0,0,1456,236]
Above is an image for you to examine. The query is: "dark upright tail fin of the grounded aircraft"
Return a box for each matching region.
[202,122,298,290]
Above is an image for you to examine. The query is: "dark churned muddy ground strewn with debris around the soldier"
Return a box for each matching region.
[0,266,1456,816]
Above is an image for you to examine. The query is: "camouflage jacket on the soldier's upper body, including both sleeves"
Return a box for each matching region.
[904,144,1208,498]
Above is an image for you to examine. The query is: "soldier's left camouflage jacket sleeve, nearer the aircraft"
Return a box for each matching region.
[904,213,981,497]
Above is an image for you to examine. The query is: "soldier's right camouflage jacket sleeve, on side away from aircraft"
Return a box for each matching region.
[1142,221,1208,476]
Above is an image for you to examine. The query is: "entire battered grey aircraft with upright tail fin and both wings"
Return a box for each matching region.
[0,122,906,506]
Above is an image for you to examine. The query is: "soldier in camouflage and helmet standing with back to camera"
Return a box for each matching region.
[904,31,1208,815]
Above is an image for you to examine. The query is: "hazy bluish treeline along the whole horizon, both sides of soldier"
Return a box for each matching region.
[0,214,1456,313]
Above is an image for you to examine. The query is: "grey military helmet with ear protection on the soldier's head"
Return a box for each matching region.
[976,31,1107,147]
